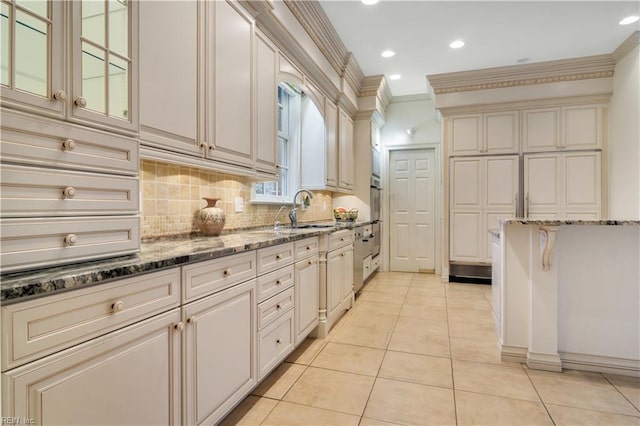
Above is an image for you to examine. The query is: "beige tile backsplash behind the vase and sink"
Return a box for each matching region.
[140,160,333,238]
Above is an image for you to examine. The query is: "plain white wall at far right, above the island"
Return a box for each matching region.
[608,42,640,219]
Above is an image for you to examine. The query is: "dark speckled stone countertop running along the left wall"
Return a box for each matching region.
[0,222,371,305]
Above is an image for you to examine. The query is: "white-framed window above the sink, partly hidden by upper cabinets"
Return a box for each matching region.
[252,83,303,203]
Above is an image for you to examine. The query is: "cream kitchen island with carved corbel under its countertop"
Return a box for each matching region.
[492,219,640,376]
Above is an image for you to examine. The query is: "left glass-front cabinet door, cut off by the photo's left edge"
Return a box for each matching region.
[0,0,67,117]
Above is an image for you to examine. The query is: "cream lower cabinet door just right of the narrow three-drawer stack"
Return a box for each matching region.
[295,255,320,345]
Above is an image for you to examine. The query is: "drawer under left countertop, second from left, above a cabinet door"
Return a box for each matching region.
[182,250,256,303]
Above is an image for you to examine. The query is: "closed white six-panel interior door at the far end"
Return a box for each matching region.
[389,149,435,272]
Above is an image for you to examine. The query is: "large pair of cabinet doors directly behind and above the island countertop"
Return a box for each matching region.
[524,151,602,219]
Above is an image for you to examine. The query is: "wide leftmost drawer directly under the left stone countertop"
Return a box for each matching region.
[2,268,180,371]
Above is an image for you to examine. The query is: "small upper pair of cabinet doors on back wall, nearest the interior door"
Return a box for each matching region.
[448,111,520,156]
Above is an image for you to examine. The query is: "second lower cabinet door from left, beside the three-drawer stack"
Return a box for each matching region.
[182,279,257,425]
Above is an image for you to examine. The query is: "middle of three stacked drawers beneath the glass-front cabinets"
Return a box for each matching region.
[1,165,139,217]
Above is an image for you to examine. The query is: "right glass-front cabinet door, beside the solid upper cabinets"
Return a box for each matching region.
[69,0,138,132]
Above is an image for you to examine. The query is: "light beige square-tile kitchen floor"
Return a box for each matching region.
[223,272,640,426]
